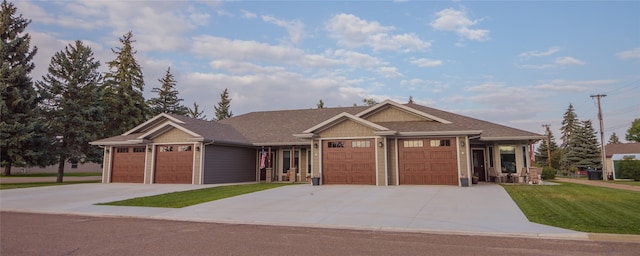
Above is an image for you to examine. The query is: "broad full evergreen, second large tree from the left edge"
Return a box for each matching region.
[37,40,104,182]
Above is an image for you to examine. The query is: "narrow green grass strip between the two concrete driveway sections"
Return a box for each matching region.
[99,183,291,208]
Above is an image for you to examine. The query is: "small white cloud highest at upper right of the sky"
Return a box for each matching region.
[430,8,489,41]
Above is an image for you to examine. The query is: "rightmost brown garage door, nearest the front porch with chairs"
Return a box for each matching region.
[398,138,458,185]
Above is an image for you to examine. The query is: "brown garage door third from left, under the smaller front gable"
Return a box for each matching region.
[322,139,376,185]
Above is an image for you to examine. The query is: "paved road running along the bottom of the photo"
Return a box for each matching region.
[0,212,640,256]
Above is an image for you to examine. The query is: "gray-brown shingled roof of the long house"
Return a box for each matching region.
[92,104,544,146]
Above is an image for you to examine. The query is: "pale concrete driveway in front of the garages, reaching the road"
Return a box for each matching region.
[0,184,588,239]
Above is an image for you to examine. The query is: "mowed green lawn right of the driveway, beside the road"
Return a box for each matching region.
[503,183,640,234]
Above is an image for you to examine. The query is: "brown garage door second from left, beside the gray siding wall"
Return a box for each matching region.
[153,145,193,184]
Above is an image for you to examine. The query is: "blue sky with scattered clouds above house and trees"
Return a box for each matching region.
[14,0,640,142]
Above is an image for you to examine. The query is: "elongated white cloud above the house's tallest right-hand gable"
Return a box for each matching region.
[325,14,431,52]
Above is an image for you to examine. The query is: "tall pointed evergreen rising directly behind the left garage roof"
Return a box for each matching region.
[104,31,147,136]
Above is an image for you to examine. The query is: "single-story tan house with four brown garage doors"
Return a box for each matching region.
[91,100,544,186]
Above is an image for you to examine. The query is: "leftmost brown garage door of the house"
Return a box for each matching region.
[111,147,145,183]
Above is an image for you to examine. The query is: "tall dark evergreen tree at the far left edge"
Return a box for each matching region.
[0,0,52,176]
